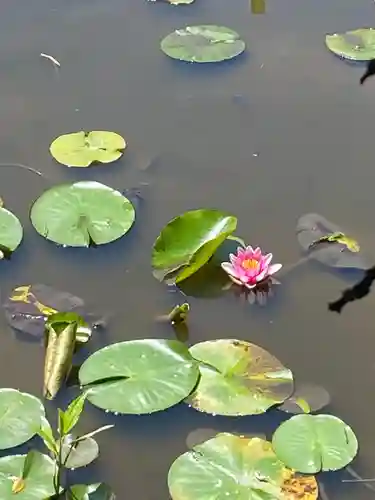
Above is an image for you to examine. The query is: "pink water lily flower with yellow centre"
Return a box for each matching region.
[221,246,282,288]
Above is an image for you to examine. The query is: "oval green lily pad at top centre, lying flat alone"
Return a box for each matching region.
[160,25,245,63]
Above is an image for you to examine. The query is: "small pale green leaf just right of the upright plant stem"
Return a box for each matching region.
[61,435,99,469]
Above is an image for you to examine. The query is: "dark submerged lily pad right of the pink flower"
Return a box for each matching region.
[296,213,369,269]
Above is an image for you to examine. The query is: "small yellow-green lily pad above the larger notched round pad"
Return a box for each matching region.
[50,130,126,167]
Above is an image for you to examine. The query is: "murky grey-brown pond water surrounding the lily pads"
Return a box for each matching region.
[0,0,375,500]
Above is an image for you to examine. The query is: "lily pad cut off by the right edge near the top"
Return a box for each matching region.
[326,28,375,61]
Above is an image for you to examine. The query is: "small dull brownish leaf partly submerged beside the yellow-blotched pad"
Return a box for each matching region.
[278,382,331,413]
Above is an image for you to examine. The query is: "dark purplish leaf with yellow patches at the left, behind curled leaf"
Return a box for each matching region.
[3,284,101,342]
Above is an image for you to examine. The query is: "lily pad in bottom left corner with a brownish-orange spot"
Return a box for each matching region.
[0,452,55,500]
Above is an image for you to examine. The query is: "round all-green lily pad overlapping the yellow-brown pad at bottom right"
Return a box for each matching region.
[272,415,358,474]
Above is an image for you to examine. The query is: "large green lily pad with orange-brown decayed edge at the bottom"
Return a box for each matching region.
[168,433,318,500]
